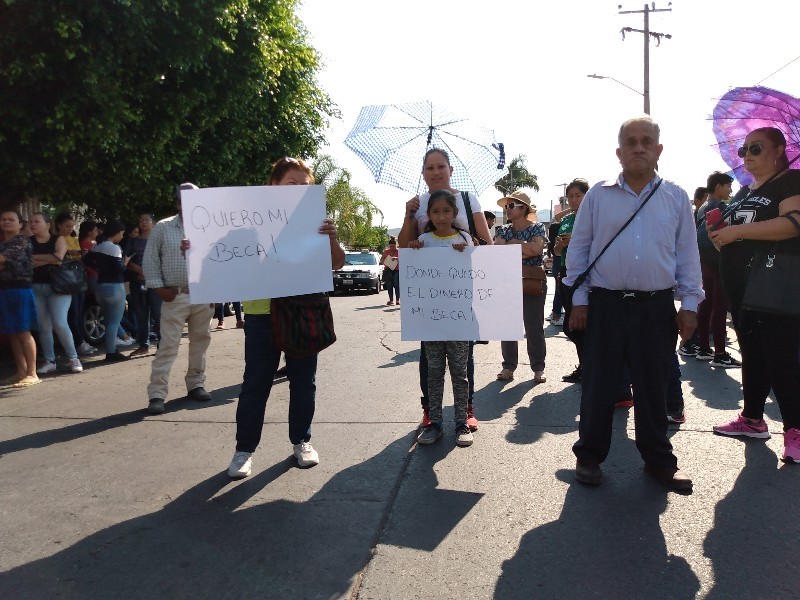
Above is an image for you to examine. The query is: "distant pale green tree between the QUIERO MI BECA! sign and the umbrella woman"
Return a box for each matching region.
[313,154,388,248]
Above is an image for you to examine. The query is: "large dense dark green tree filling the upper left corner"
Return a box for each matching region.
[0,0,337,217]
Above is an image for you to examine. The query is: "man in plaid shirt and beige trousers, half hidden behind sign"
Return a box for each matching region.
[142,183,214,414]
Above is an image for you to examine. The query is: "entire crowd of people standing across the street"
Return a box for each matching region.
[0,117,800,490]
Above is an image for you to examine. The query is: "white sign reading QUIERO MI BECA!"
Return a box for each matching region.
[181,185,333,304]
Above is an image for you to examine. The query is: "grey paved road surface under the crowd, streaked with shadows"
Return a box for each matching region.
[0,294,800,600]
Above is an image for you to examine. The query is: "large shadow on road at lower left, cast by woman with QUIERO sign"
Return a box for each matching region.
[0,436,418,600]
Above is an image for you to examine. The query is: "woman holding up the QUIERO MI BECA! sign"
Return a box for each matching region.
[228,157,344,479]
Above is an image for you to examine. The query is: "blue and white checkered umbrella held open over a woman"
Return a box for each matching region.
[344,101,506,195]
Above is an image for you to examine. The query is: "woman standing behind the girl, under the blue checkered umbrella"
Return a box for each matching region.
[397,148,492,431]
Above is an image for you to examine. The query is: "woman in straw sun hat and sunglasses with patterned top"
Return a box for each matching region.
[494,192,547,383]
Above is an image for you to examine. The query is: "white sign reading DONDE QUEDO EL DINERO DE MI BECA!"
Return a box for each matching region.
[400,244,524,341]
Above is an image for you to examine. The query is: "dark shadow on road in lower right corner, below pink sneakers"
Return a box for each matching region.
[703,439,800,600]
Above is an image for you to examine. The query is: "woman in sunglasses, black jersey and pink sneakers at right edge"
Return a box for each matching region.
[709,127,800,463]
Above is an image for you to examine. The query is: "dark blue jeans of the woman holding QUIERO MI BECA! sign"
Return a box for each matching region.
[236,315,317,452]
